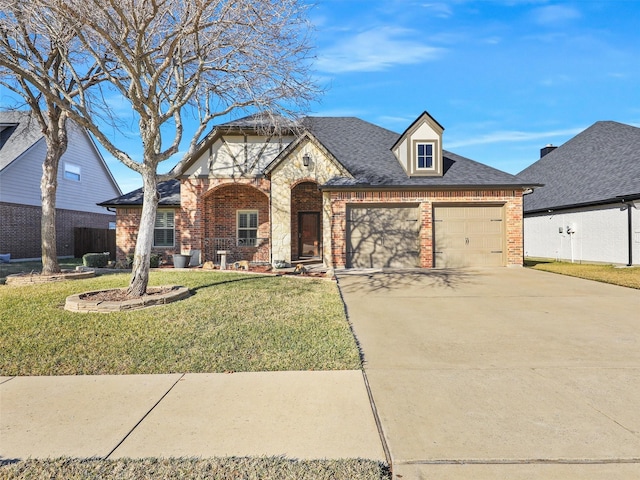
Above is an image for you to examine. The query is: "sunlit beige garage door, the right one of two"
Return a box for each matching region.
[433,205,505,267]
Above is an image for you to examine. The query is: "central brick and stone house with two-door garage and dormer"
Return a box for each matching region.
[101,112,535,268]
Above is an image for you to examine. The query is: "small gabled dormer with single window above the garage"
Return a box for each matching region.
[391,111,444,177]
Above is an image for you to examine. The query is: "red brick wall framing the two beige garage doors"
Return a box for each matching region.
[330,190,523,268]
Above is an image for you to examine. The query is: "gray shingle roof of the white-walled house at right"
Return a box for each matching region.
[518,121,640,212]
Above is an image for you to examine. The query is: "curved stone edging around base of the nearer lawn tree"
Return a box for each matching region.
[64,286,191,313]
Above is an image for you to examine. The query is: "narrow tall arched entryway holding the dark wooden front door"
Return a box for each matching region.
[291,181,322,260]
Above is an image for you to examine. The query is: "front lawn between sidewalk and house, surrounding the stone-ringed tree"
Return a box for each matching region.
[0,270,361,376]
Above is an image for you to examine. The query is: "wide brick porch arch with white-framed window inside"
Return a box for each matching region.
[204,183,270,263]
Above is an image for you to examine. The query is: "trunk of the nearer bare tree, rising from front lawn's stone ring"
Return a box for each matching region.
[127,170,158,297]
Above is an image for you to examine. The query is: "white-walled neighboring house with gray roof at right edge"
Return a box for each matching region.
[518,121,640,265]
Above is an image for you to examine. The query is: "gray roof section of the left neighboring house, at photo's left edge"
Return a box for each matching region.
[0,111,43,171]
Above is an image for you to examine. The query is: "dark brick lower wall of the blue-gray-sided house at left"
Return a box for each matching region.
[0,203,116,259]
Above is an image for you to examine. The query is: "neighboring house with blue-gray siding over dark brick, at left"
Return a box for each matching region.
[0,111,121,259]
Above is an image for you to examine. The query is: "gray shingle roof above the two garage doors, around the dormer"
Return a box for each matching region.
[304,117,527,187]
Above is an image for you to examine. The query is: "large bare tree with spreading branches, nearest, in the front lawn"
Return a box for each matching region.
[15,0,317,296]
